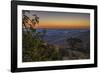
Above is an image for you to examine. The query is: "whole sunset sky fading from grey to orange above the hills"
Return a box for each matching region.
[22,10,90,29]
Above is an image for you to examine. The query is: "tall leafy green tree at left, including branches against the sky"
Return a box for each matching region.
[22,11,59,62]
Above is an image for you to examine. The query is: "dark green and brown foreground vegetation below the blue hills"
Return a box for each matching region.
[22,29,90,62]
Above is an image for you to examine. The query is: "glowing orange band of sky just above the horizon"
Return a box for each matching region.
[35,19,90,29]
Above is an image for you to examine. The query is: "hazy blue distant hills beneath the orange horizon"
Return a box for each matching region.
[37,29,90,47]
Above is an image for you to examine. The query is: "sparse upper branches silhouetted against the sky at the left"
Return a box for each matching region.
[22,10,39,32]
